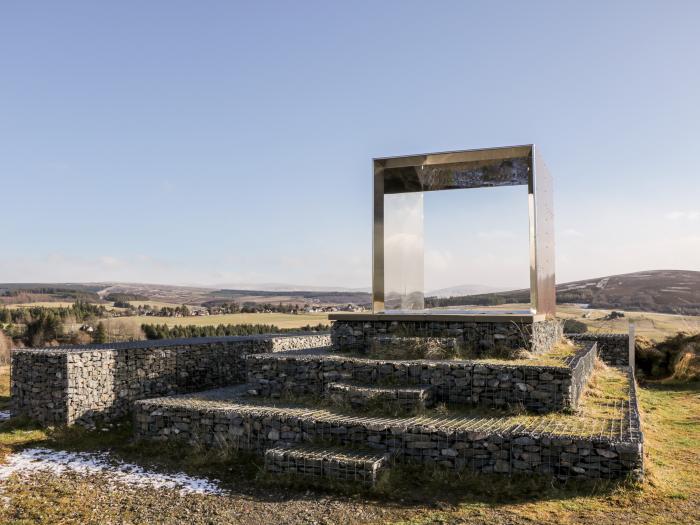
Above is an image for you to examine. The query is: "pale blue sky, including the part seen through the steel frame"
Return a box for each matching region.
[0,0,700,287]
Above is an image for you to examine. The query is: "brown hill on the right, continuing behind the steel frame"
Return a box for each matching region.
[426,270,700,315]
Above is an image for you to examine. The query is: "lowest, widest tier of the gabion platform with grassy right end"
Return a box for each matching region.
[134,368,643,478]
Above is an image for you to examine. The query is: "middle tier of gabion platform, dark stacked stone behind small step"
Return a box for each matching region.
[248,343,596,413]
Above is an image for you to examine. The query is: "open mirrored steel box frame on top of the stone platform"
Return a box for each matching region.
[372,145,556,315]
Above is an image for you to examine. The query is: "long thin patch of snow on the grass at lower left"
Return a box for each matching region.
[0,448,225,495]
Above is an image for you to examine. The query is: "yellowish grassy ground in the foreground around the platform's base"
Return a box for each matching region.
[0,368,700,525]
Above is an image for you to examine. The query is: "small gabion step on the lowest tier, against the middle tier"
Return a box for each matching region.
[326,381,435,412]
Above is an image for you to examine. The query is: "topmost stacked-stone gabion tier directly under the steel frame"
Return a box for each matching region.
[331,320,562,358]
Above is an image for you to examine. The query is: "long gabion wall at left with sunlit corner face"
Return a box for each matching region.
[10,335,330,426]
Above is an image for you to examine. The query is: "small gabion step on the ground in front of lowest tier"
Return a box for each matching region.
[265,444,388,485]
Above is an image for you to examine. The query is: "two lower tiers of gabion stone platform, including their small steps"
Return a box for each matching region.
[134,338,643,485]
